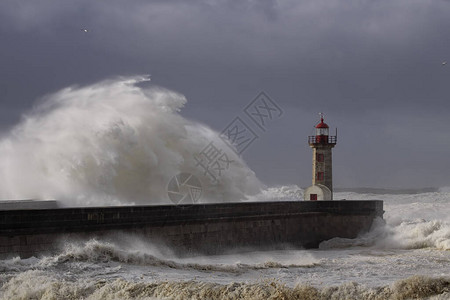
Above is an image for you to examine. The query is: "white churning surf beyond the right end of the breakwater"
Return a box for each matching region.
[326,188,450,250]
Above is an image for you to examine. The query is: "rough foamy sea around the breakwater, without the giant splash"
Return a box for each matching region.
[0,186,450,299]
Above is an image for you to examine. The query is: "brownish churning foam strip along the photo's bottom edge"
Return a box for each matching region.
[0,271,450,300]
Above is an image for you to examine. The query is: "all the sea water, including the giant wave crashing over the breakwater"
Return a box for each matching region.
[0,76,450,299]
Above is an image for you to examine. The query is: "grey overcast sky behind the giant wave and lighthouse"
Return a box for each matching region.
[0,0,450,188]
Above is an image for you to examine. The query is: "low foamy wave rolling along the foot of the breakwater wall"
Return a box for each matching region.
[37,236,319,273]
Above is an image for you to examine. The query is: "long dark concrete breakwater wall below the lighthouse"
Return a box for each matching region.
[0,200,383,258]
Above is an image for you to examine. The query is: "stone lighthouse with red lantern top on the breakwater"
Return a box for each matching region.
[304,114,337,201]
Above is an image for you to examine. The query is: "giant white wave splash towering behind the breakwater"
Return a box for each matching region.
[0,76,262,206]
